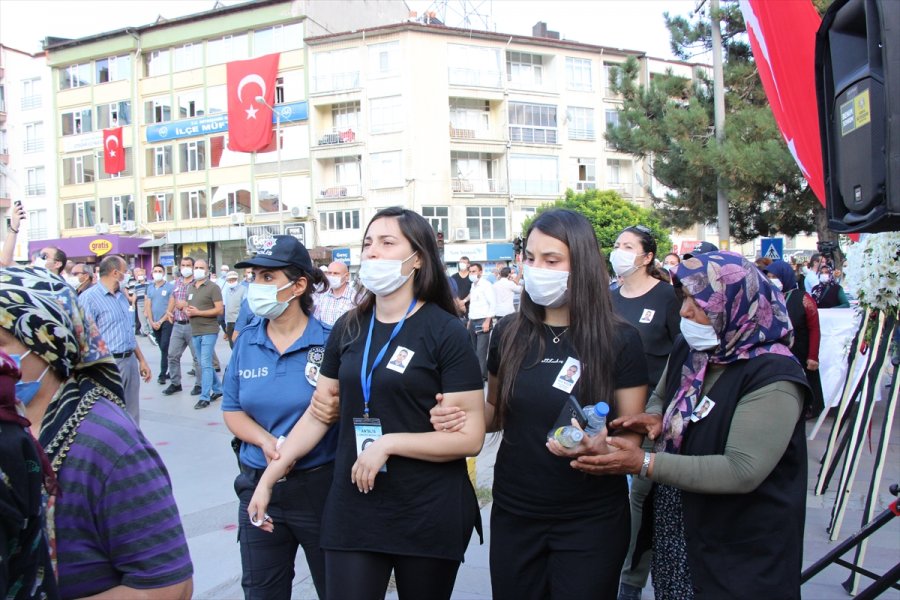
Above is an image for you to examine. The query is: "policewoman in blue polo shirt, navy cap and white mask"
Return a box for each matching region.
[222,235,337,599]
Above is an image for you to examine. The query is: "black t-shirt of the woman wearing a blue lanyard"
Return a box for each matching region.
[321,304,483,560]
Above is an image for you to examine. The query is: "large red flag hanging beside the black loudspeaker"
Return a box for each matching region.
[740,0,825,205]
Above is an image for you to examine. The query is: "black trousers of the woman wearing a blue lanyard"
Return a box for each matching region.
[325,550,459,600]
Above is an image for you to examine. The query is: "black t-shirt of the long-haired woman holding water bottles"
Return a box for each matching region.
[488,315,647,519]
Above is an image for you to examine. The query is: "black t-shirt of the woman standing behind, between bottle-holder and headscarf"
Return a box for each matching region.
[612,281,681,390]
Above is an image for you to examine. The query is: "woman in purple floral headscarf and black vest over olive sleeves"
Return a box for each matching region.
[548,252,808,600]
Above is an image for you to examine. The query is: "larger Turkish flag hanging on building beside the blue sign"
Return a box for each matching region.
[226,53,279,152]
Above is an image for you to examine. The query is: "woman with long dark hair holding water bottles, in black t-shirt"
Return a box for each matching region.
[432,209,647,600]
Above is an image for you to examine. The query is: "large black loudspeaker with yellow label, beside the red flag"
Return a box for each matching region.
[816,0,900,233]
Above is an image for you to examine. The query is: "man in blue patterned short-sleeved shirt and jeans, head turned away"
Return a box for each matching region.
[78,256,150,423]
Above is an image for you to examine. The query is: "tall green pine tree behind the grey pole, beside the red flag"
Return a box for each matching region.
[607,1,833,242]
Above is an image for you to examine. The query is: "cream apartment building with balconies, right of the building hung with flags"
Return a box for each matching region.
[306,21,680,264]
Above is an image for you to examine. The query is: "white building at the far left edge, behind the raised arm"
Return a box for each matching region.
[0,44,58,261]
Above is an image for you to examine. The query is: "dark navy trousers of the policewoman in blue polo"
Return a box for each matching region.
[234,463,334,600]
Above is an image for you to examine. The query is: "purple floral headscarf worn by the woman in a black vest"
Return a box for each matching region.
[657,252,796,453]
